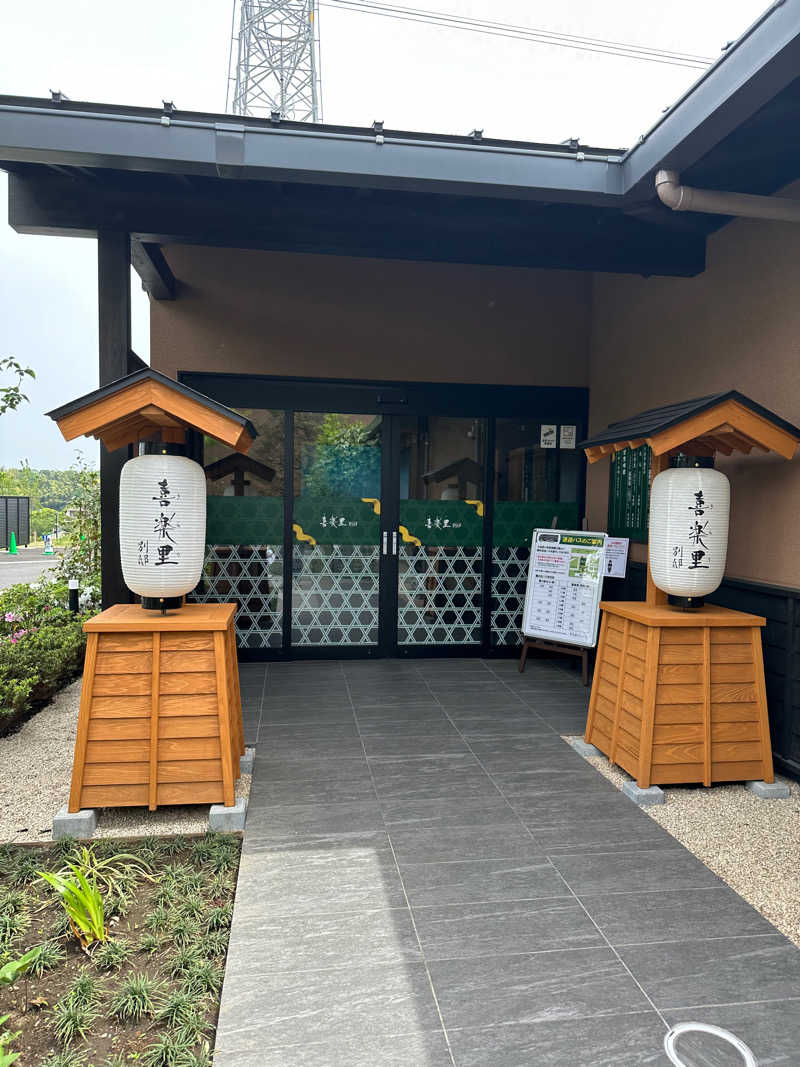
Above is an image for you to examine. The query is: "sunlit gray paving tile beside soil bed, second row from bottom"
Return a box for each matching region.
[218,962,439,1054]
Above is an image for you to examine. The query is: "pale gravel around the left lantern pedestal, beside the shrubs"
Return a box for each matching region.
[0,680,251,842]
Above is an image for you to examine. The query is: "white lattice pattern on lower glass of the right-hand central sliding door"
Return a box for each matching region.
[397,544,483,644]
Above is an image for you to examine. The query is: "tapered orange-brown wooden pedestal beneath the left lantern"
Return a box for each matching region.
[68,604,244,812]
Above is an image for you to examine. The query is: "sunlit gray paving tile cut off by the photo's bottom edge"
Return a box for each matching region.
[214,1031,452,1067]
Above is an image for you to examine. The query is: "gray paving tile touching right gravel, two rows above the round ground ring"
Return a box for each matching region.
[580,886,774,945]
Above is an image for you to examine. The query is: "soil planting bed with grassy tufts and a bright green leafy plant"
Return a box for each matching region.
[0,834,239,1067]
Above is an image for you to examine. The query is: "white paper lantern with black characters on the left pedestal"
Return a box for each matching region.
[119,455,206,607]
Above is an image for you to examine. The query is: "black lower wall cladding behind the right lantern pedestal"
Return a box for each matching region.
[603,563,800,781]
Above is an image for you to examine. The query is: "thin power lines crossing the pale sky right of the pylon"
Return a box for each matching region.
[321,0,714,69]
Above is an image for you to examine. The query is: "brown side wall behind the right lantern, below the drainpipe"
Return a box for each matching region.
[587,194,800,588]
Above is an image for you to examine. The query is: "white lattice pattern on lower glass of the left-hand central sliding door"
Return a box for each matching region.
[291,544,380,647]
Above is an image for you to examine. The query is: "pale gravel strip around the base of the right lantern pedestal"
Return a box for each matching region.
[564,737,800,945]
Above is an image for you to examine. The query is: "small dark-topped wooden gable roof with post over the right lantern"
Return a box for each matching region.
[579,389,800,605]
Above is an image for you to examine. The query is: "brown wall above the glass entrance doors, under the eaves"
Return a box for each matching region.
[150,245,591,386]
